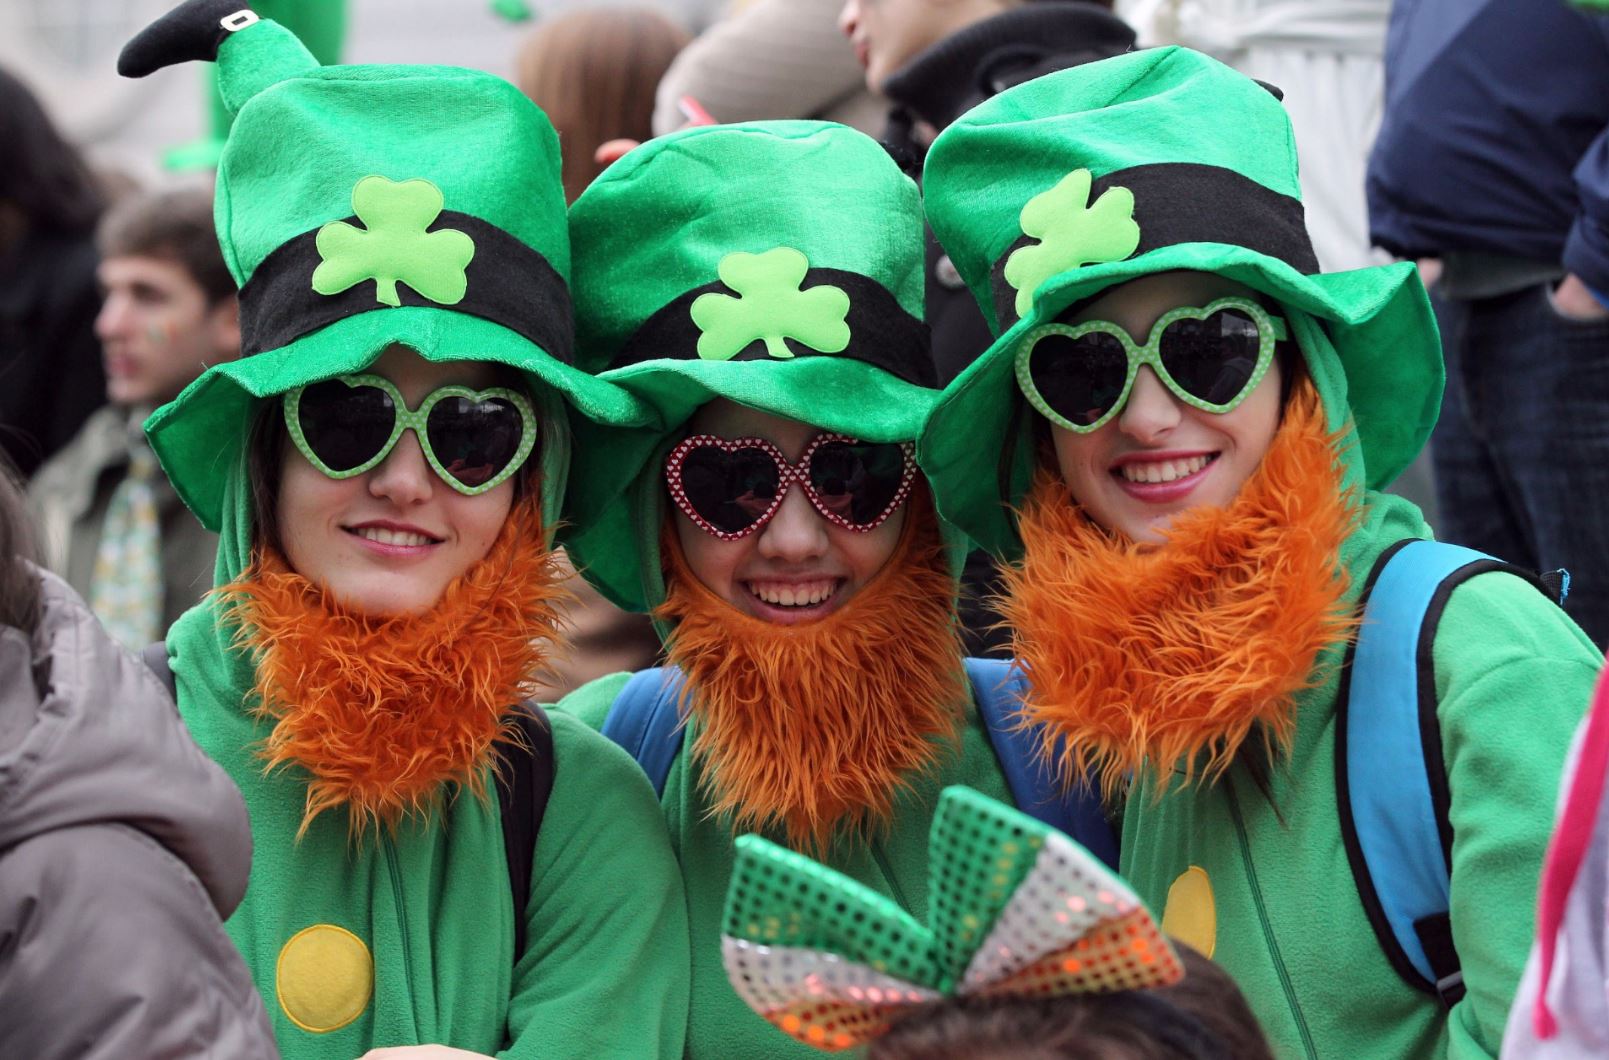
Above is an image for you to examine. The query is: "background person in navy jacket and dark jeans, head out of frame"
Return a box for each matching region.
[1368,0,1609,645]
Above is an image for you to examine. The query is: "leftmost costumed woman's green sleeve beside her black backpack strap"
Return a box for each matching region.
[499,711,690,1060]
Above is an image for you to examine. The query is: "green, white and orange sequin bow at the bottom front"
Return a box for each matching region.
[721,787,1183,1050]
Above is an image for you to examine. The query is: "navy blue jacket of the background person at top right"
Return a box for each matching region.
[1368,0,1609,286]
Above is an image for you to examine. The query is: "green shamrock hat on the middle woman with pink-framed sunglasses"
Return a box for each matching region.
[565,121,938,611]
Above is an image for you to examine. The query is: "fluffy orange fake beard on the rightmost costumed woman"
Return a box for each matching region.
[1001,380,1358,798]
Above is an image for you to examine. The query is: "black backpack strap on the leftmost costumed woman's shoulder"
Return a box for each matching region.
[494,701,553,962]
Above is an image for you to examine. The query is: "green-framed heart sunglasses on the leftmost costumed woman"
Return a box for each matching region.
[285,375,536,495]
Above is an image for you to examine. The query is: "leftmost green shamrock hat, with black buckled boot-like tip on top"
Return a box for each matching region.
[117,0,645,529]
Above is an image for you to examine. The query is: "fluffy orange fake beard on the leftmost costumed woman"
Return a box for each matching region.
[219,499,563,835]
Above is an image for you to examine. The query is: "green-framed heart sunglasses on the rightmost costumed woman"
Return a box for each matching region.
[1017,298,1289,434]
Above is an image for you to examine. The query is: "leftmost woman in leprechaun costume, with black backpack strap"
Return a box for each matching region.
[122,0,687,1060]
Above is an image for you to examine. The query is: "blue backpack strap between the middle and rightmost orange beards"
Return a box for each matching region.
[967,659,1117,872]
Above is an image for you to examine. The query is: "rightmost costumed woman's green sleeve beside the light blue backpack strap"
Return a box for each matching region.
[1434,573,1603,1060]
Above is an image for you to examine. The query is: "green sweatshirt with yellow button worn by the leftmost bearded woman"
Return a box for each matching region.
[167,572,687,1060]
